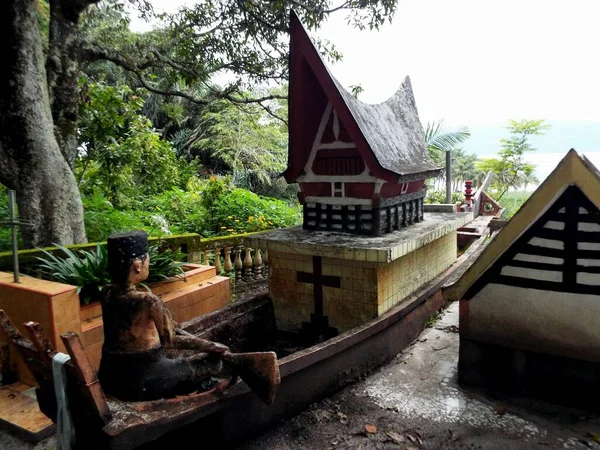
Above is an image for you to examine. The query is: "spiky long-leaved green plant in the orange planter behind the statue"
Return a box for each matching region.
[37,244,185,305]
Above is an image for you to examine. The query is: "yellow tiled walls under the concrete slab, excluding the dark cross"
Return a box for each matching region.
[269,232,457,333]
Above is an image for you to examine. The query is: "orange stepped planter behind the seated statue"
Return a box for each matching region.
[0,264,231,385]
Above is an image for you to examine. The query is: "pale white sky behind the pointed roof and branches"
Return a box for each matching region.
[127,0,600,183]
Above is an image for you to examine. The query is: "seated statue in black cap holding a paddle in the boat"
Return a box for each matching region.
[98,231,279,403]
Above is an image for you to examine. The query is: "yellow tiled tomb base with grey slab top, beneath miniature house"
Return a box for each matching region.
[249,213,472,333]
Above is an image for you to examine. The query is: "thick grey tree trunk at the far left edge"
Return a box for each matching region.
[0,0,85,247]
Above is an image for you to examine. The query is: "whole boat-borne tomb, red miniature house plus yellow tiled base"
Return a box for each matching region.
[248,13,472,340]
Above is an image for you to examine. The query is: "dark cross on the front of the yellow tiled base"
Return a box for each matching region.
[296,256,341,344]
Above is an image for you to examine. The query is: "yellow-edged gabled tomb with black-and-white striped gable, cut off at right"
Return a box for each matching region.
[448,150,600,407]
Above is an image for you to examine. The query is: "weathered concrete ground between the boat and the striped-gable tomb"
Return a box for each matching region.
[0,303,600,450]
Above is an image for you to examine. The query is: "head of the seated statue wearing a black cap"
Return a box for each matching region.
[106,231,150,284]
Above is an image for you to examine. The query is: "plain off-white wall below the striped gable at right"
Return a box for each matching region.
[460,284,600,362]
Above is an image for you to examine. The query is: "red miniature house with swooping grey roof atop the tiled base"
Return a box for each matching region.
[283,12,441,236]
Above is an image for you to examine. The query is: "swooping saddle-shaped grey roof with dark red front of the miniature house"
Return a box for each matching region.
[283,11,442,182]
